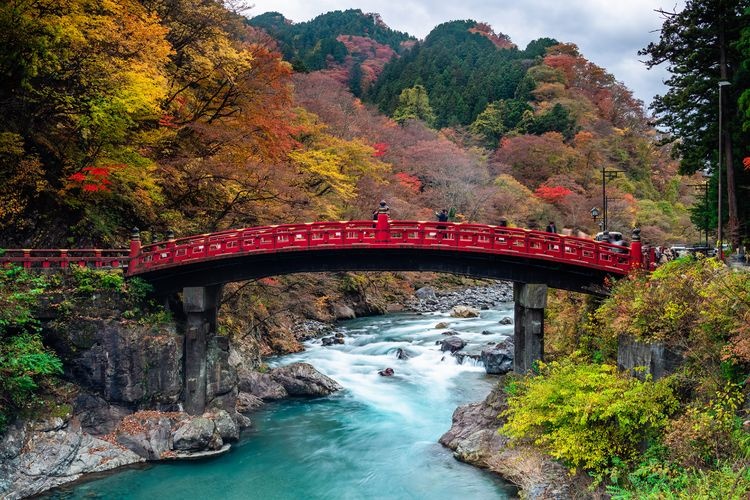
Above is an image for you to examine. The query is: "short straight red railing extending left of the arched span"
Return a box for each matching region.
[0,248,130,269]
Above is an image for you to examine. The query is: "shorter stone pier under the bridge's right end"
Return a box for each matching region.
[513,283,547,373]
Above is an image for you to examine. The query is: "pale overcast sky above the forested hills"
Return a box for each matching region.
[245,0,684,106]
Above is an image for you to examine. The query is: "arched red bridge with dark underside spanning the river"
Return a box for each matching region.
[0,214,642,294]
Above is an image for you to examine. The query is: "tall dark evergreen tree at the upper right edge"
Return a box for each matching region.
[640,0,750,245]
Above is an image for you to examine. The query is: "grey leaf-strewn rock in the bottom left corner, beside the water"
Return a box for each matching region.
[0,418,144,500]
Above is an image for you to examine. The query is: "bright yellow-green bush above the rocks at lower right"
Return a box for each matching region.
[500,356,677,478]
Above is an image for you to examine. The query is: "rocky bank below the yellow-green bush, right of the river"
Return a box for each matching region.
[440,385,597,500]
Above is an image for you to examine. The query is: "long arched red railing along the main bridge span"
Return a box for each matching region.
[128,220,632,274]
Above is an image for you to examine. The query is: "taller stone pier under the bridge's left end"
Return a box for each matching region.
[182,285,222,415]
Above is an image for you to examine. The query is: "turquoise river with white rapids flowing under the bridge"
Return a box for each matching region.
[51,308,516,500]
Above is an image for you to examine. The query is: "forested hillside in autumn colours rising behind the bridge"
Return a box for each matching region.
[0,0,724,250]
